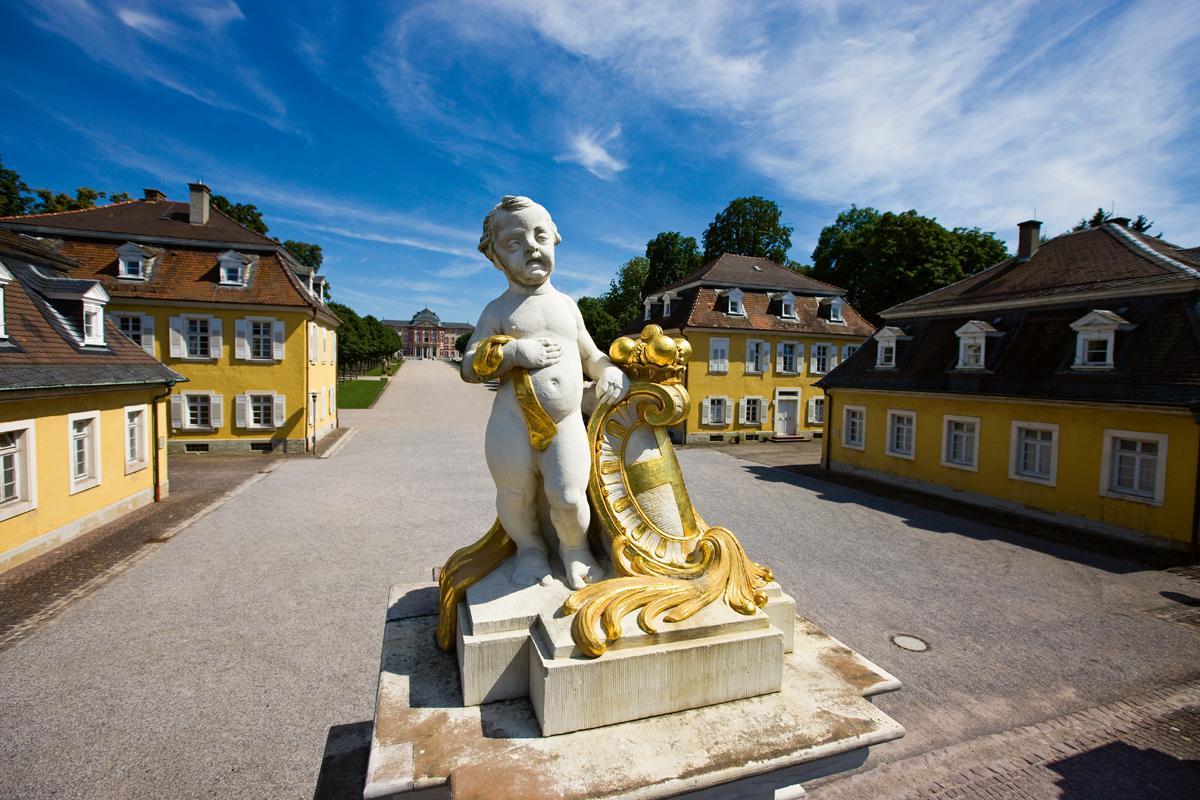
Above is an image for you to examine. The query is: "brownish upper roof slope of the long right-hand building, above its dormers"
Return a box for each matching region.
[881,222,1200,320]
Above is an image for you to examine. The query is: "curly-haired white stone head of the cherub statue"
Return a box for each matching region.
[479,194,563,287]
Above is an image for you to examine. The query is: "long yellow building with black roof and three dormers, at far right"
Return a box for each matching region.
[821,219,1200,552]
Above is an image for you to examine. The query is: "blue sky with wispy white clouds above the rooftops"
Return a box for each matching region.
[0,0,1200,321]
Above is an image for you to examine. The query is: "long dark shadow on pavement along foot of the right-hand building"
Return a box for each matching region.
[743,455,1190,575]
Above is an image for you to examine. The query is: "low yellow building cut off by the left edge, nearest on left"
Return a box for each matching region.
[0,230,182,572]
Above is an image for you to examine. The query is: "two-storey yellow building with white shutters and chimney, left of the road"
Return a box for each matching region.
[0,184,340,452]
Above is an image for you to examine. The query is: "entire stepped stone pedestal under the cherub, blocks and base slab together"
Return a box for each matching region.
[365,584,904,800]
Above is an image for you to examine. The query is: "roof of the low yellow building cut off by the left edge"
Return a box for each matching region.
[0,235,186,392]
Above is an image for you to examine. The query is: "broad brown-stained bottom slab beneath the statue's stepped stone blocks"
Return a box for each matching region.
[364,585,904,800]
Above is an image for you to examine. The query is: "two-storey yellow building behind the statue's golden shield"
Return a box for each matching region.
[636,253,875,443]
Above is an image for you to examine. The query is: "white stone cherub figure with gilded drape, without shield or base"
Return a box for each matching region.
[462,196,629,589]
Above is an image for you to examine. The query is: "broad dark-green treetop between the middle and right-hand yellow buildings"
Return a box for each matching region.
[811,205,1008,319]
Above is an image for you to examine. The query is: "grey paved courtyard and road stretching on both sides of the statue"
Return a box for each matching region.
[0,362,1200,798]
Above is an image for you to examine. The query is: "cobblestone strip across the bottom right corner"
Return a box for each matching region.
[808,679,1200,800]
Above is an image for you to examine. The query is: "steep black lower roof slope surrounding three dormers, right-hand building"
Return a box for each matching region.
[817,291,1200,405]
